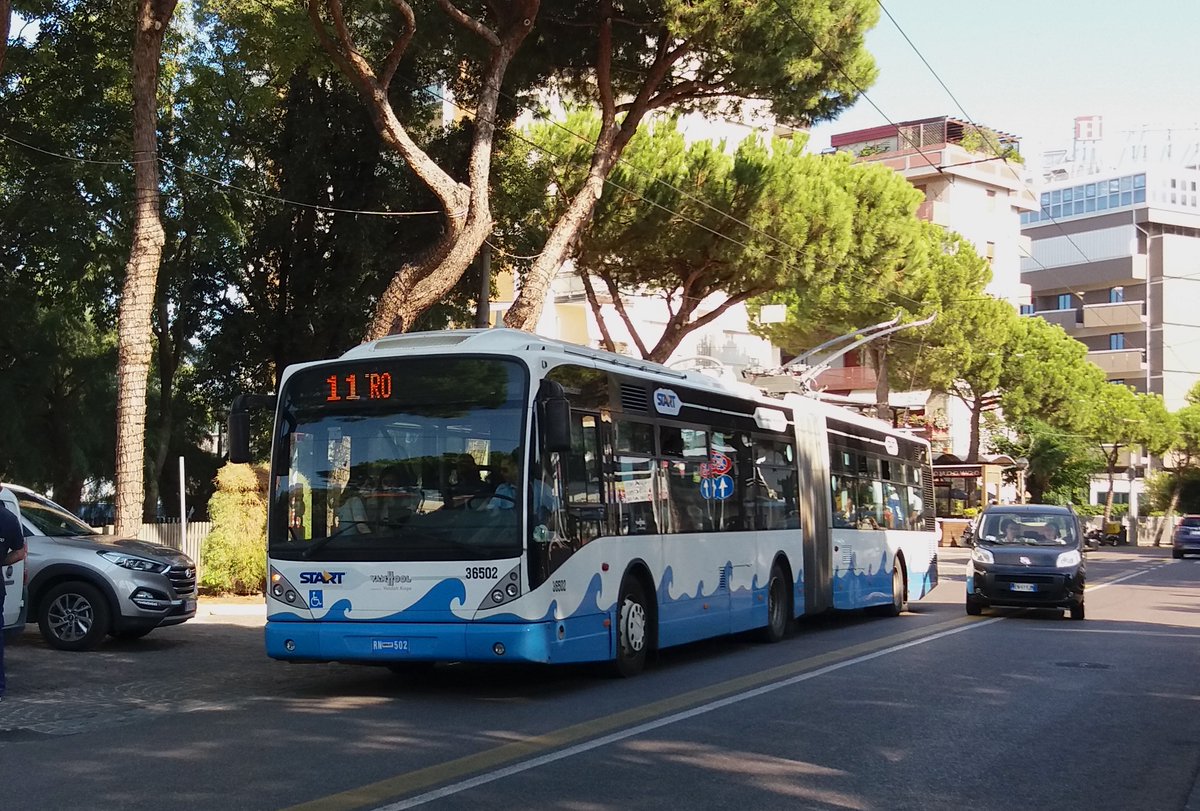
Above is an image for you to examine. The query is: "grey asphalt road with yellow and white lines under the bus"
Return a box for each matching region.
[0,548,1200,811]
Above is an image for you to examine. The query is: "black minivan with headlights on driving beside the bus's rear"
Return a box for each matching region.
[967,504,1087,619]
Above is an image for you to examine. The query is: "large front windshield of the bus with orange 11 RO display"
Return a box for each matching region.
[268,356,528,560]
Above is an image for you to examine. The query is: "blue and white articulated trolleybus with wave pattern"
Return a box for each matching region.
[229,330,937,675]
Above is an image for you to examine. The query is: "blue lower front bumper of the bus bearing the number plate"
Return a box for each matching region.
[266,614,613,665]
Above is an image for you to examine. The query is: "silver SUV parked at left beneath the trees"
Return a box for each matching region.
[4,483,196,650]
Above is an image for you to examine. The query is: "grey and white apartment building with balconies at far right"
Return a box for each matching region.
[1021,163,1200,410]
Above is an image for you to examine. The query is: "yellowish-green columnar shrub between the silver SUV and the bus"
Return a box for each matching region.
[200,464,269,594]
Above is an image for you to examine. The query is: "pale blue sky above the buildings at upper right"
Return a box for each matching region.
[810,0,1200,164]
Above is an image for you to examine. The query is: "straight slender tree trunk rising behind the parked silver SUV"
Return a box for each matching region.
[116,0,176,536]
